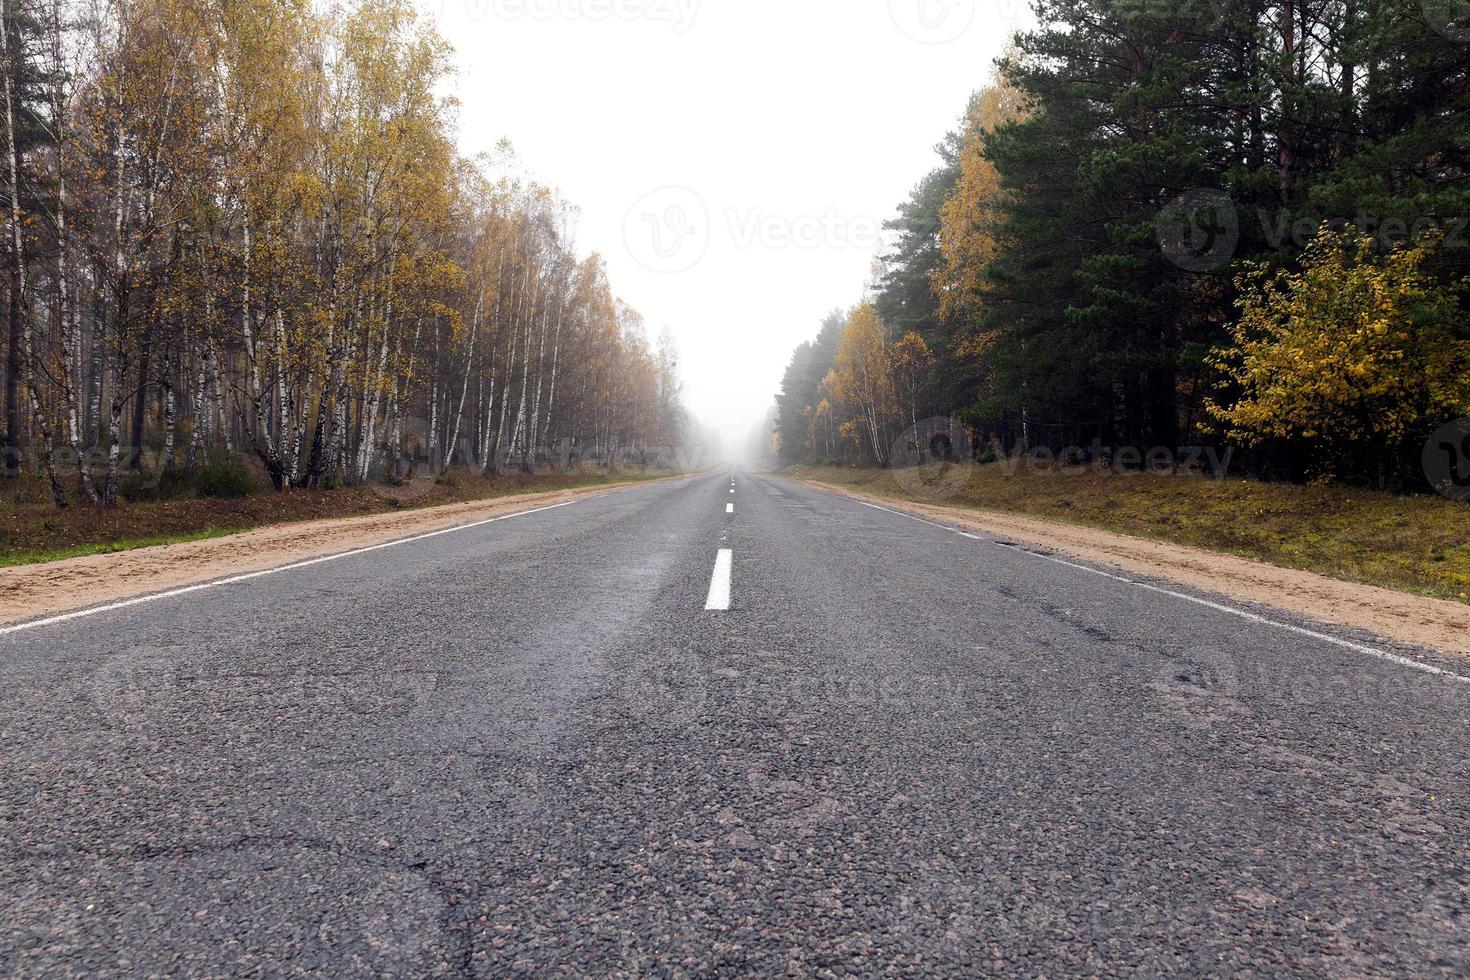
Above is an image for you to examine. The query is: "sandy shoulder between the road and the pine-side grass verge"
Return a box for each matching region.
[798,480,1470,654]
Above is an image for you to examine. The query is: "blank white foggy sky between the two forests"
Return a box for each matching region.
[417,0,1028,447]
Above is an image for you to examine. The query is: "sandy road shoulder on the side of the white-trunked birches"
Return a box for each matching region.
[0,483,658,624]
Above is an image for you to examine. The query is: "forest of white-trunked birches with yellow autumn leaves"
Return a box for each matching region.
[0,0,684,507]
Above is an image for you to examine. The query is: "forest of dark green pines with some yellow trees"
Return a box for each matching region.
[773,0,1470,491]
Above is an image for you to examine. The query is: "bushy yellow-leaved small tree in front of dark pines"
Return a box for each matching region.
[1208,228,1470,483]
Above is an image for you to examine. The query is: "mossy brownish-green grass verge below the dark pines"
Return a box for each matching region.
[786,464,1470,602]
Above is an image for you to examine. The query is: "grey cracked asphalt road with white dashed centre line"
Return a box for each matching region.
[0,472,1470,977]
